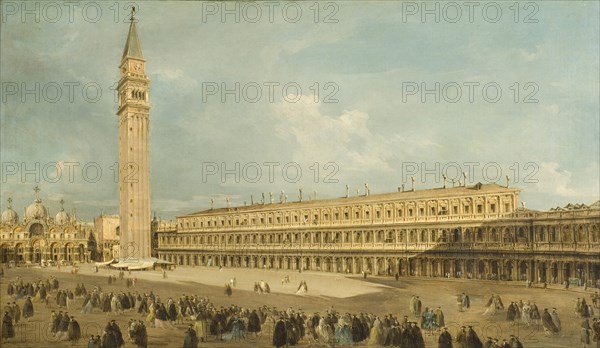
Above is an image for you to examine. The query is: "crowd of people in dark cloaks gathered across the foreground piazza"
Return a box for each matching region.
[2,272,600,348]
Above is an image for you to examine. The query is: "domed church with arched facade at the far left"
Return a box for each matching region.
[0,186,96,265]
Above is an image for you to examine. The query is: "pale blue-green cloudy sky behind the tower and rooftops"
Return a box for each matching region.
[0,1,600,221]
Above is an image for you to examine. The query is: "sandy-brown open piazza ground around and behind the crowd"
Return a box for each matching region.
[1,264,597,348]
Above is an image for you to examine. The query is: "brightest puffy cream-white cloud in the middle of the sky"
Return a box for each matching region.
[274,96,441,173]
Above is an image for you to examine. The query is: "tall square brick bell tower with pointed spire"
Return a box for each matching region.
[117,8,151,259]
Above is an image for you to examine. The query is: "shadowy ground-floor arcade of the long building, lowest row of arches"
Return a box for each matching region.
[158,252,600,286]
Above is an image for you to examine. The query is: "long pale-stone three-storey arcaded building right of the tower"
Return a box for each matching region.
[157,184,600,286]
